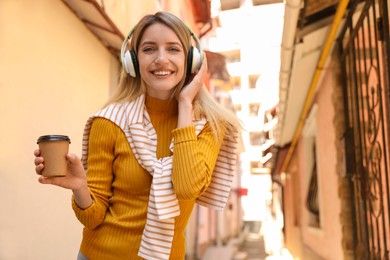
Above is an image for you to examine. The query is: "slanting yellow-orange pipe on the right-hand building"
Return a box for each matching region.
[280,0,349,173]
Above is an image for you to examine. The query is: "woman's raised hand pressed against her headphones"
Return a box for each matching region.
[178,55,207,104]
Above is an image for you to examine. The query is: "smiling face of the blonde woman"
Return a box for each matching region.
[137,23,185,99]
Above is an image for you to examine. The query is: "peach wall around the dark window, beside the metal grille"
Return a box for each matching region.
[284,61,344,260]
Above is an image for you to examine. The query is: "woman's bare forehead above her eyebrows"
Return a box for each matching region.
[140,23,181,43]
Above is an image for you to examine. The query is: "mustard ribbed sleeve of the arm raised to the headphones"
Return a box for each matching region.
[172,124,223,200]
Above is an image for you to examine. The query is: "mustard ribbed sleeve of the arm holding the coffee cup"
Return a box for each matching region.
[72,118,116,229]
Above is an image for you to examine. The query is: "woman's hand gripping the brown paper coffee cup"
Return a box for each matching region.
[34,149,87,190]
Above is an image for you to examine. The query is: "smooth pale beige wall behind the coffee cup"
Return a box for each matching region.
[0,0,117,260]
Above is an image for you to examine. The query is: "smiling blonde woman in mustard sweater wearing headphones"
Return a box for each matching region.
[34,12,240,260]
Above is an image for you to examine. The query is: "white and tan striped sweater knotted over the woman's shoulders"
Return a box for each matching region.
[82,94,237,260]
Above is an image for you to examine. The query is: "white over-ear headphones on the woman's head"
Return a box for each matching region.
[121,26,203,79]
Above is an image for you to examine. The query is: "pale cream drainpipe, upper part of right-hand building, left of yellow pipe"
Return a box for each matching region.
[276,0,301,145]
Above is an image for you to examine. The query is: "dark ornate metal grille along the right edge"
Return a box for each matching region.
[339,0,390,259]
